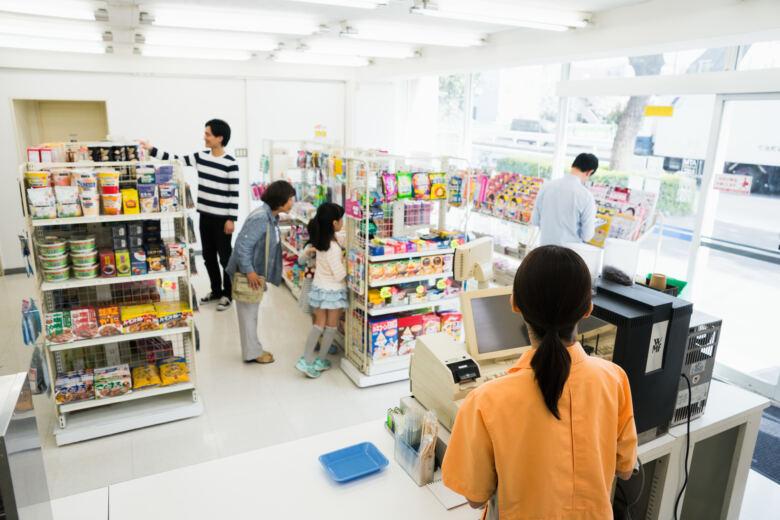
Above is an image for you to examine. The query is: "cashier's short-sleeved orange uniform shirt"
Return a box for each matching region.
[443,343,637,520]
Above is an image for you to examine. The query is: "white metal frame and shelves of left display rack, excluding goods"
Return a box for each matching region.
[19,161,203,445]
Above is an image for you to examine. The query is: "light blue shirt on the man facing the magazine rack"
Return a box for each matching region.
[531,173,596,246]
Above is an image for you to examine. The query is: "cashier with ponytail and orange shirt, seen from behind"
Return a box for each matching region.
[443,246,637,520]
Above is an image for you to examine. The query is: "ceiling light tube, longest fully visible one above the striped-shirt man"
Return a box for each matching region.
[149,5,320,35]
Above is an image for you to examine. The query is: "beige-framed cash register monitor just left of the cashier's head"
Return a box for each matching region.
[460,286,531,361]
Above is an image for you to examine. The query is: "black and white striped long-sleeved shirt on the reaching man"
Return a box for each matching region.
[152,148,238,220]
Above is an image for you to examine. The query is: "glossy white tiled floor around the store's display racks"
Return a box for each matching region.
[0,270,780,520]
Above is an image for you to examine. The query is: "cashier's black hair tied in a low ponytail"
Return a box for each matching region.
[512,246,591,419]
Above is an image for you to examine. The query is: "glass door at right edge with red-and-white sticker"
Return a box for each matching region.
[688,93,780,401]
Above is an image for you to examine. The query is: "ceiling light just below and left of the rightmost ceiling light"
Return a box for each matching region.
[341,20,487,47]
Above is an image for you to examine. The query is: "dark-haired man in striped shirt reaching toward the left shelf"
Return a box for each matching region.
[142,119,238,311]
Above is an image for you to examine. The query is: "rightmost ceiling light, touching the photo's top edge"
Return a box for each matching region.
[411,0,590,31]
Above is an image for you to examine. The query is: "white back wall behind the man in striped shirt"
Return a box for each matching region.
[0,69,344,269]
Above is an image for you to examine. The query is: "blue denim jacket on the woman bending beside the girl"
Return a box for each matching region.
[225,202,282,286]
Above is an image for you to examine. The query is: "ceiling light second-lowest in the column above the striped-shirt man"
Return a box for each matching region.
[143,27,279,51]
